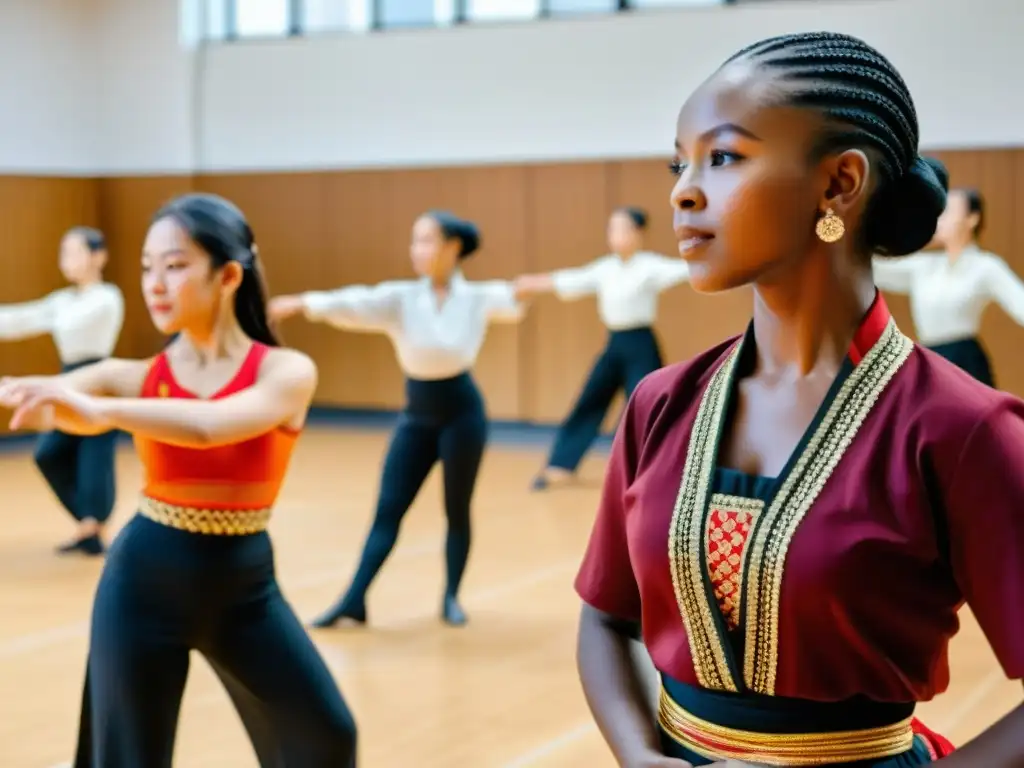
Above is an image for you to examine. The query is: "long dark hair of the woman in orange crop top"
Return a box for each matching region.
[153,193,281,347]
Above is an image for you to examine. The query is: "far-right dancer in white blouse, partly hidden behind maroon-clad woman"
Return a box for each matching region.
[873,188,1024,386]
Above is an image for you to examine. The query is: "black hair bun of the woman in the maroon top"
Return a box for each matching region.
[865,155,949,256]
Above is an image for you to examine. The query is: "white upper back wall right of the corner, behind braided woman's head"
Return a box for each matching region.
[197,0,1024,170]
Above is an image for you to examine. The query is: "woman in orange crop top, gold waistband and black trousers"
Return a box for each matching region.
[0,195,355,768]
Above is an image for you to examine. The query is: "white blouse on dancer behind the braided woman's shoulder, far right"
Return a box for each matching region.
[872,248,1024,346]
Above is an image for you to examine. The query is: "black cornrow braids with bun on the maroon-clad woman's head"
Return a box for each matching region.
[725,32,949,256]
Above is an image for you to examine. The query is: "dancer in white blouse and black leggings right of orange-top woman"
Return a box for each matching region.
[270,211,523,627]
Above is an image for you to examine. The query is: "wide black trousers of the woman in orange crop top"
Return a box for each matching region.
[74,515,355,768]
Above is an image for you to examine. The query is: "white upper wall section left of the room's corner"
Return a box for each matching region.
[0,0,97,175]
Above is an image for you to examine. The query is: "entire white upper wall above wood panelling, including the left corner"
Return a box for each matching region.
[0,0,1024,175]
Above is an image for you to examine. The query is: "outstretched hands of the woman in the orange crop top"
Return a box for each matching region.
[0,377,109,429]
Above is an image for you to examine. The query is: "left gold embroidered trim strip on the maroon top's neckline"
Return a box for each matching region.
[669,343,741,692]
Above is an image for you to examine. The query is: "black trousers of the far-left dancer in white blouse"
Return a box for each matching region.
[33,360,118,522]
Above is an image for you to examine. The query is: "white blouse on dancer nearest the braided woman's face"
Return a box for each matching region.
[551,251,690,331]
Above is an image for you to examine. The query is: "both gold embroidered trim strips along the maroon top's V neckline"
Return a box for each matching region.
[669,319,913,695]
